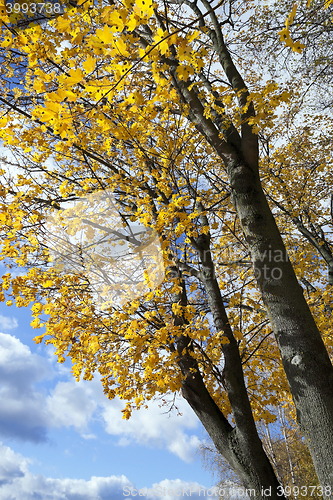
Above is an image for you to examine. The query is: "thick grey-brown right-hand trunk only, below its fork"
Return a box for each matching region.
[228,153,333,489]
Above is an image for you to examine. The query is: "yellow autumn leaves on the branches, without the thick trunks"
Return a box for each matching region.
[0,0,331,428]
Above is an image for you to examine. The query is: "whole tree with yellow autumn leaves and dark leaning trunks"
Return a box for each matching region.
[0,0,333,498]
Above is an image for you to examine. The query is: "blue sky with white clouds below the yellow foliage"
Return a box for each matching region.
[0,267,218,500]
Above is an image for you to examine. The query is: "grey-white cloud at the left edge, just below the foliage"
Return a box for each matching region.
[0,333,103,442]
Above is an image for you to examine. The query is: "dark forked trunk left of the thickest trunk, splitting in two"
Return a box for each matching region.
[174,245,281,499]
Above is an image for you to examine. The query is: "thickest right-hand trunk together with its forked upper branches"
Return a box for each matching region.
[167,19,333,484]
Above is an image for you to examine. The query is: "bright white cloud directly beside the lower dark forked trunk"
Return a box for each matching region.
[102,399,200,462]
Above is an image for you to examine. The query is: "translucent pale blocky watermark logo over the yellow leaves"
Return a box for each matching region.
[45,191,165,309]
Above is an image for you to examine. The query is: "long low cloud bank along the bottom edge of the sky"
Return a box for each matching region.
[0,443,216,500]
